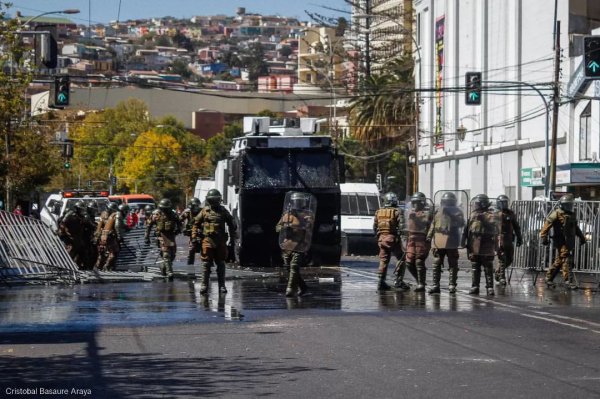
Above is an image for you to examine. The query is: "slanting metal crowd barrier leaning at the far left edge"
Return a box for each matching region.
[0,211,79,284]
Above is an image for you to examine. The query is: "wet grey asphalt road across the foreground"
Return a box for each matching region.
[0,258,600,398]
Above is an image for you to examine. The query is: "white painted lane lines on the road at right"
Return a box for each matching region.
[339,266,600,334]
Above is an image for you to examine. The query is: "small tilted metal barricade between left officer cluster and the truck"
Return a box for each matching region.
[115,228,161,272]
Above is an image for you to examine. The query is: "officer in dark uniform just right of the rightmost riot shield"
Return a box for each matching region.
[494,195,523,285]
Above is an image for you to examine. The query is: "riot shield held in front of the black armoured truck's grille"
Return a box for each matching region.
[277,191,317,252]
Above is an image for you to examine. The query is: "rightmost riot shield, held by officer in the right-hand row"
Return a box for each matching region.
[467,196,502,256]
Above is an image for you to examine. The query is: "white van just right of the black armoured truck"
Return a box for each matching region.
[340,183,381,255]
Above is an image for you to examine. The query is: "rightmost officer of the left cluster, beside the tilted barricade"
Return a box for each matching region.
[95,202,124,271]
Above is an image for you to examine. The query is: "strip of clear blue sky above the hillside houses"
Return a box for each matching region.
[9,0,350,24]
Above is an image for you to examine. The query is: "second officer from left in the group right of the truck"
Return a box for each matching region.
[395,192,433,290]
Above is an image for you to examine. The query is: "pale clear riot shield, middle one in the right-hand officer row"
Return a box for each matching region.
[431,190,469,249]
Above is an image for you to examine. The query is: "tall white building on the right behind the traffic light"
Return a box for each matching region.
[414,0,600,199]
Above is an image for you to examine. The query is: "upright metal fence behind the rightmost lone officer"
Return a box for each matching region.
[511,201,600,273]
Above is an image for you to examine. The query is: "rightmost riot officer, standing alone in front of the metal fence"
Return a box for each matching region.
[540,194,586,289]
